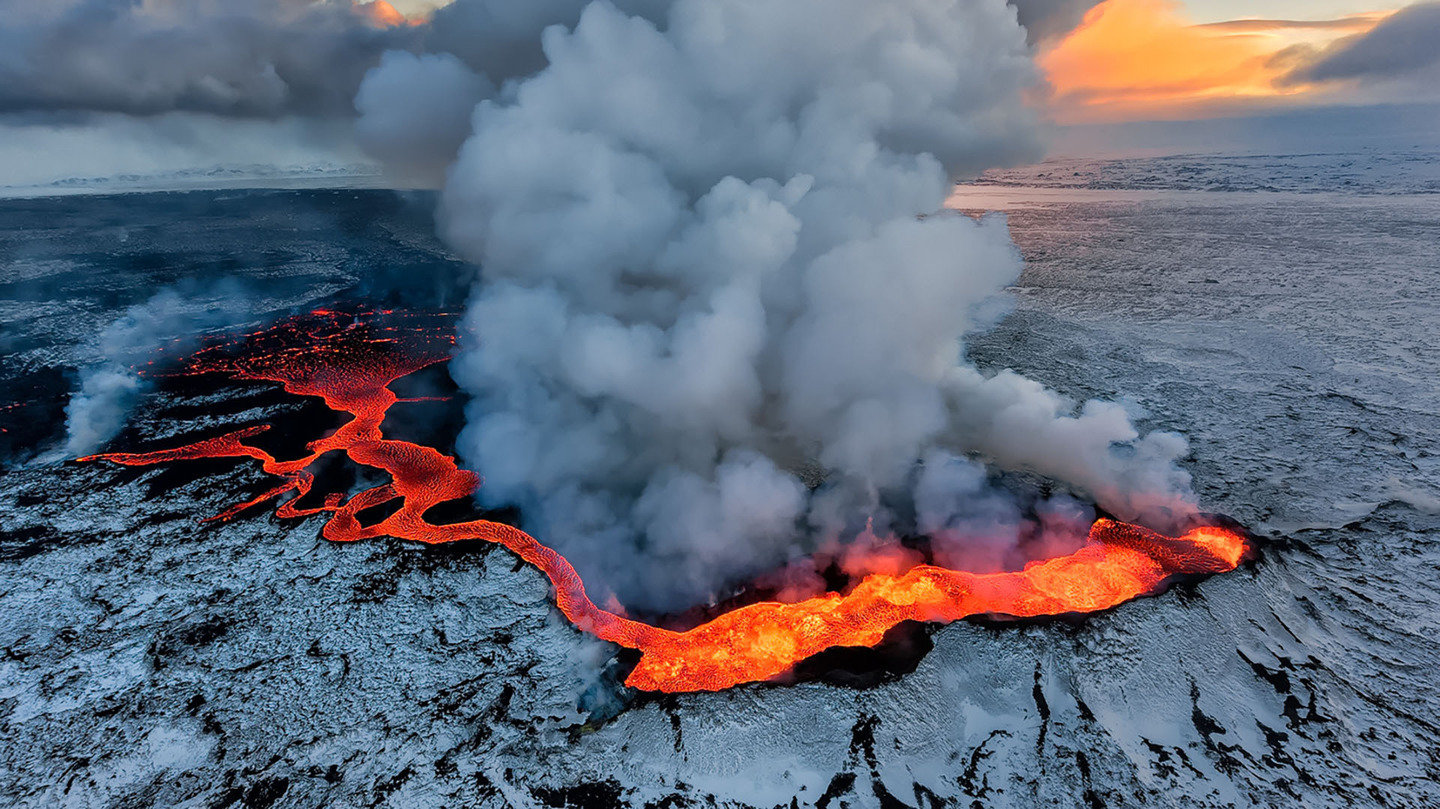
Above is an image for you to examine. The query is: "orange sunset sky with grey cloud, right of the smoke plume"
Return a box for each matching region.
[1040,0,1440,124]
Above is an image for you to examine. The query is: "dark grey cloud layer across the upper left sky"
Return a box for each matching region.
[0,0,419,118]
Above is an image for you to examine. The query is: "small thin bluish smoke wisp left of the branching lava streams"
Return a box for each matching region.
[62,281,255,458]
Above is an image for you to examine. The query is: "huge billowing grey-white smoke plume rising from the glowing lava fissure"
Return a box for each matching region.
[345,0,1192,609]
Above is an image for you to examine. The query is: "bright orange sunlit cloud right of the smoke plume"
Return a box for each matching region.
[1040,0,1385,122]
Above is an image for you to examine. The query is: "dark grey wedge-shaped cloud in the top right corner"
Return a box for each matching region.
[1286,3,1440,83]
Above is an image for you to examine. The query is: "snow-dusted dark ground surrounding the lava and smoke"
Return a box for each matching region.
[0,179,1440,808]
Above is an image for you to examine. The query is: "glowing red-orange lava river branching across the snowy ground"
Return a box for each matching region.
[81,305,1250,692]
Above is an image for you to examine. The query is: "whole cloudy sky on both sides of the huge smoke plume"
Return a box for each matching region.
[0,0,1440,193]
